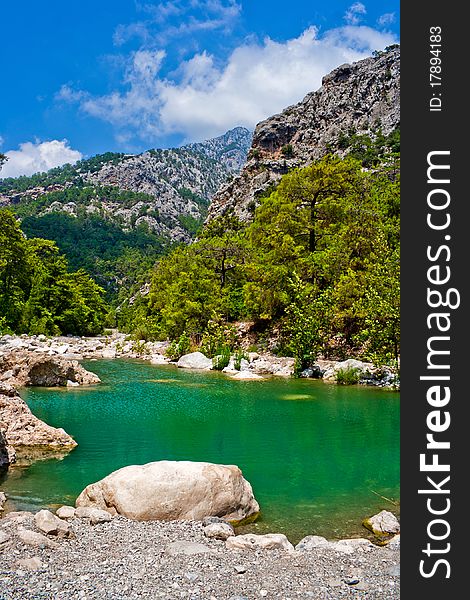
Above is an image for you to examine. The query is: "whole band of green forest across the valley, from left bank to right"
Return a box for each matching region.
[0,144,400,371]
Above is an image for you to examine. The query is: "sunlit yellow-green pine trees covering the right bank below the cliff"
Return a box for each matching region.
[120,156,399,369]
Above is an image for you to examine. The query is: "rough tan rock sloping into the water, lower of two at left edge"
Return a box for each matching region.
[0,383,77,452]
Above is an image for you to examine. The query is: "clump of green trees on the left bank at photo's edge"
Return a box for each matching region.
[0,209,107,335]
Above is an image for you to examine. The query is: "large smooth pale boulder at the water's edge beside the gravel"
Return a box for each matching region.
[76,460,259,522]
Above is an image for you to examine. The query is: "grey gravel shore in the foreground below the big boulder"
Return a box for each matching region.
[0,513,400,600]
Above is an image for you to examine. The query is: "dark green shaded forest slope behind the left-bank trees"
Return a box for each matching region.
[7,186,173,301]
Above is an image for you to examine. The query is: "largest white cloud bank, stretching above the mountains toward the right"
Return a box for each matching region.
[62,25,397,143]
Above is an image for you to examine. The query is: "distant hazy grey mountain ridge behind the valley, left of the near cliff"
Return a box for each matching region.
[0,127,252,243]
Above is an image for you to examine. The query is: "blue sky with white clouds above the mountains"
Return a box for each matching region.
[0,0,399,177]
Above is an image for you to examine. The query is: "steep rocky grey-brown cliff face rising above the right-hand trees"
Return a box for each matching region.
[208,46,400,220]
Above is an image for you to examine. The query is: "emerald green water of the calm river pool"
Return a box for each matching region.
[1,360,400,541]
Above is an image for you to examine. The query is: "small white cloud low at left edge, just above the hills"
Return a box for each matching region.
[0,140,82,177]
